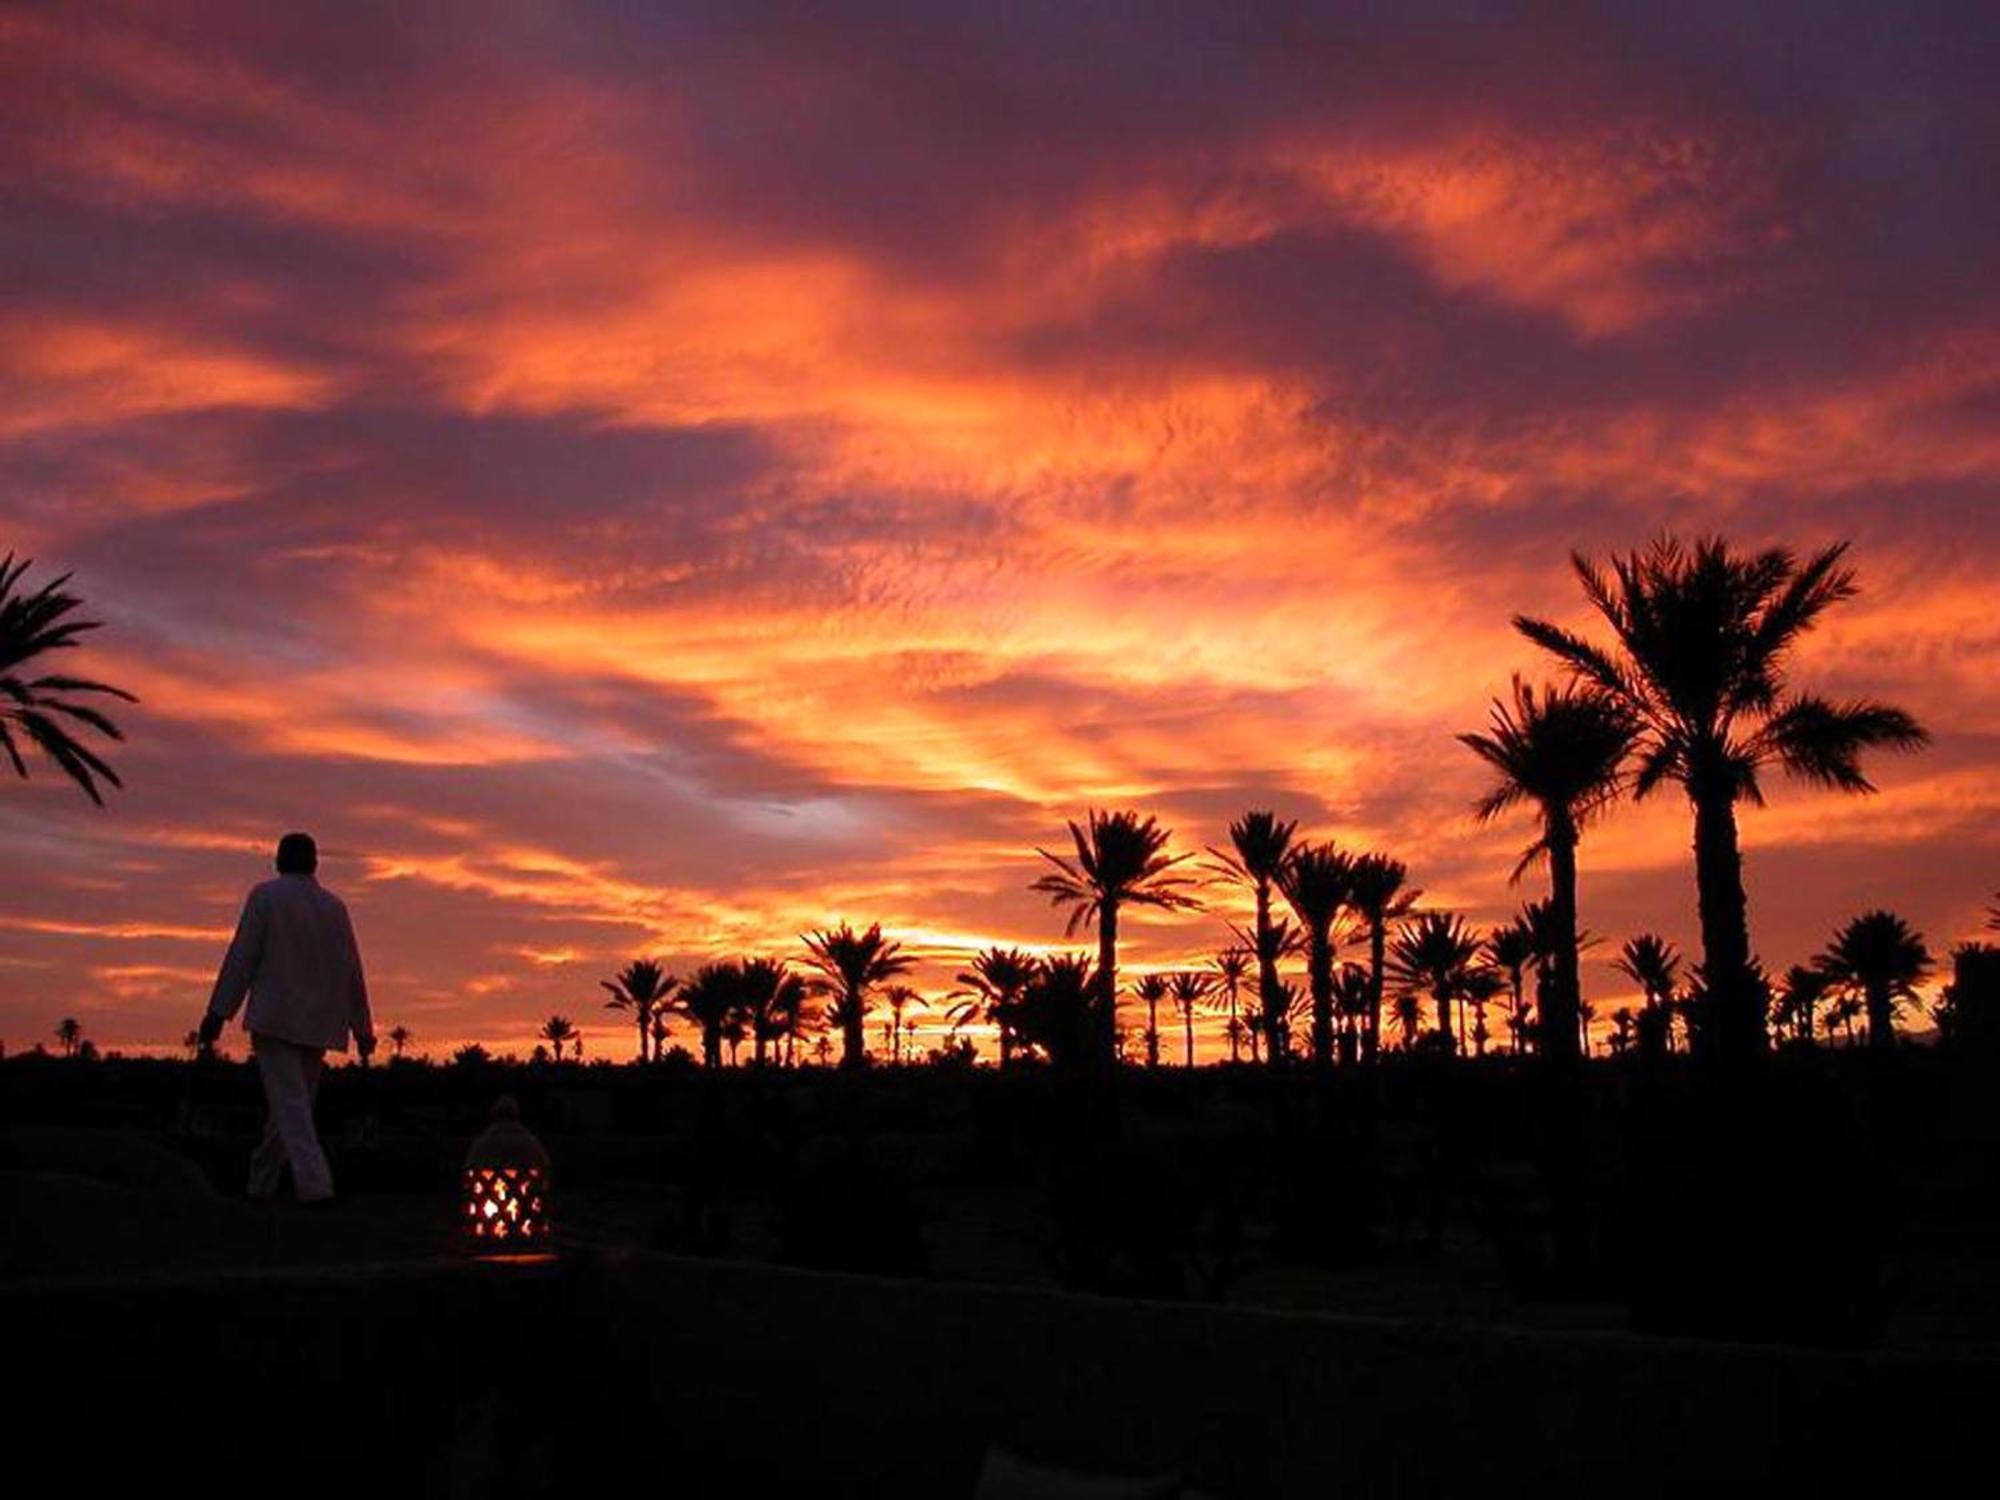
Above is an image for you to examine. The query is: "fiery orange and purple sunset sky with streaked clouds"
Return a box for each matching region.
[0,0,2000,1056]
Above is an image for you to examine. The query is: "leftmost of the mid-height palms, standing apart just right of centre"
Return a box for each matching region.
[1030,808,1196,1066]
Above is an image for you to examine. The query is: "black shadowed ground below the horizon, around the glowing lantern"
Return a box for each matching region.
[0,1050,2000,1496]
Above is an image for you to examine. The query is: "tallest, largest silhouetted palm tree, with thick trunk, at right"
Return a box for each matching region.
[1514,536,1928,1064]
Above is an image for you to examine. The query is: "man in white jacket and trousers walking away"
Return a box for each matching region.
[198,834,376,1202]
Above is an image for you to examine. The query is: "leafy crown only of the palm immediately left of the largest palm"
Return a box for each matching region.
[1458,676,1636,876]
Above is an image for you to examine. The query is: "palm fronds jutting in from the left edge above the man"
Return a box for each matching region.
[0,552,138,808]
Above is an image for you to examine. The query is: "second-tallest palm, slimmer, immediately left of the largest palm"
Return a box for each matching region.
[1458,676,1636,1064]
